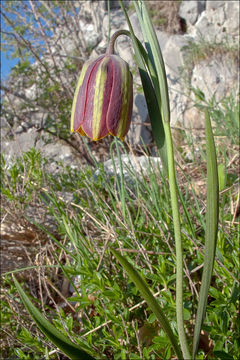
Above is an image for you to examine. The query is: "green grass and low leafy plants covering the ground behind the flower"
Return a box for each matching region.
[1,92,240,359]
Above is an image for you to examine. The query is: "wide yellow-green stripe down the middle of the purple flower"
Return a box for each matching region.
[92,56,109,141]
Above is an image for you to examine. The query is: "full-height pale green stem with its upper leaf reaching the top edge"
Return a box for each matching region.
[131,0,190,359]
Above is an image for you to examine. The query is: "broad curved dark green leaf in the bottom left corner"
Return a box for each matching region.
[13,276,94,360]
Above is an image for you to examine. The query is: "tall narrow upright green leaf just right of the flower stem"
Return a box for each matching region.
[193,110,219,358]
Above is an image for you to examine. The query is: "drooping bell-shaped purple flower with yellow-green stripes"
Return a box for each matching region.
[71,54,133,141]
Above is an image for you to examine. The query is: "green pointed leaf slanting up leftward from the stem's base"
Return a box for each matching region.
[110,249,182,359]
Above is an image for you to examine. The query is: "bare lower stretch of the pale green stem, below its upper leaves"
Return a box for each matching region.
[164,122,191,360]
